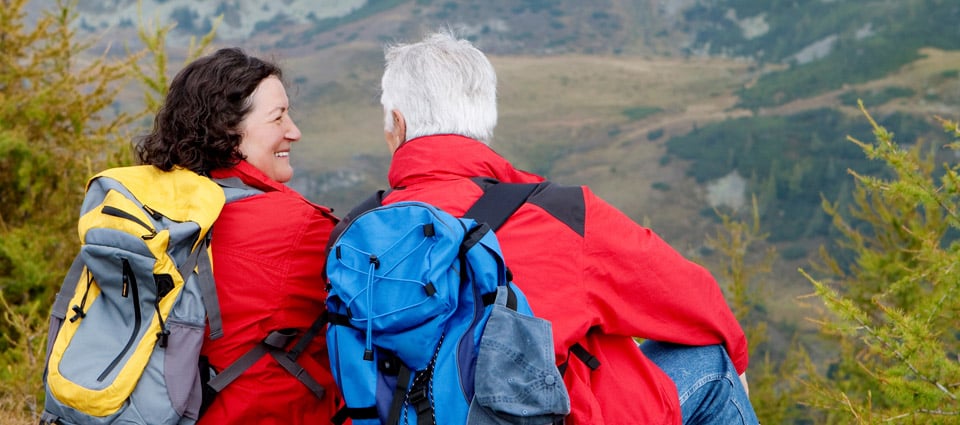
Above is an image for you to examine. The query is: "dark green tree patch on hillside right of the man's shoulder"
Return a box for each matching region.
[667,108,930,242]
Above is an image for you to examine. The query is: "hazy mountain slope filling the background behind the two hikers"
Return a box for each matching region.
[62,0,960,258]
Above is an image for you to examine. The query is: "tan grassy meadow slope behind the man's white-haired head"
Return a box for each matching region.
[288,51,748,236]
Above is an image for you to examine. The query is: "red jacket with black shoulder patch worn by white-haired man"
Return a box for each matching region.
[385,135,747,425]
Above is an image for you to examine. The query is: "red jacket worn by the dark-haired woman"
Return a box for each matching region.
[200,162,338,425]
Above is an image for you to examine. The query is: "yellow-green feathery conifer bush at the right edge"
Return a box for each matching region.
[802,108,960,424]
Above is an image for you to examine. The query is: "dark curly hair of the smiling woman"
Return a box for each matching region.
[136,48,283,175]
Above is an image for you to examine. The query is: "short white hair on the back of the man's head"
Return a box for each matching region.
[380,31,497,144]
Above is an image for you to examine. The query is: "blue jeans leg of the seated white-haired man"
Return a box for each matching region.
[640,340,759,425]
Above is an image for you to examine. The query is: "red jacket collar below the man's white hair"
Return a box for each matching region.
[387,134,543,187]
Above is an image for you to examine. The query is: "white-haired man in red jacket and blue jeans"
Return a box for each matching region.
[380,32,757,424]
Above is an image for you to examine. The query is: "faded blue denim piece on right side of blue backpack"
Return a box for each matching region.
[467,287,570,425]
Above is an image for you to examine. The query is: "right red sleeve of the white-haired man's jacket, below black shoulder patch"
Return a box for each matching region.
[583,188,748,373]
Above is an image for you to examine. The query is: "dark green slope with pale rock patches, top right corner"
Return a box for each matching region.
[685,0,960,108]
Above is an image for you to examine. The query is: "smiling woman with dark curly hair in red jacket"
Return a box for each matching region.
[137,48,338,424]
